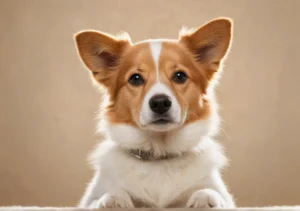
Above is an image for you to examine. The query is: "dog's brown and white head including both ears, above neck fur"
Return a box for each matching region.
[76,19,231,135]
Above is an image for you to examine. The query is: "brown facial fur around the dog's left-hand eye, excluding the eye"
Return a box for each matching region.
[107,43,155,126]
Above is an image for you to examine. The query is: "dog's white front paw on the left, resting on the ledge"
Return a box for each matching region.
[89,193,134,208]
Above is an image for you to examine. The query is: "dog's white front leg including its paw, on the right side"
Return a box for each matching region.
[187,171,235,208]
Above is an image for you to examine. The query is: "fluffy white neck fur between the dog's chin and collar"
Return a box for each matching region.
[95,102,220,156]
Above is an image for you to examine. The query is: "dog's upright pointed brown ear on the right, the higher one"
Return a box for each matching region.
[179,18,232,77]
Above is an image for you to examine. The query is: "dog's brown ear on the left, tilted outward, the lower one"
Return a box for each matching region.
[75,31,131,87]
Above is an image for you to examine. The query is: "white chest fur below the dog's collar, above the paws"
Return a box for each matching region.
[95,139,226,207]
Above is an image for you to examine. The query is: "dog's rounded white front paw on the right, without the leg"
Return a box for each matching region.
[187,189,225,208]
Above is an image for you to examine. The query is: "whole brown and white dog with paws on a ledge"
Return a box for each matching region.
[75,18,235,208]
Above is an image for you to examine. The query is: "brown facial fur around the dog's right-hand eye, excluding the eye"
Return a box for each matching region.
[159,42,209,123]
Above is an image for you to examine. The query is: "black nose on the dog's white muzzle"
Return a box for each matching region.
[149,95,172,114]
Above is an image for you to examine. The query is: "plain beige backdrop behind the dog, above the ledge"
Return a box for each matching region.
[0,0,300,206]
